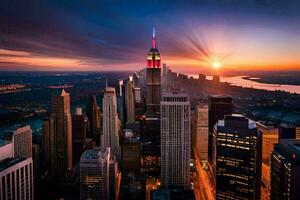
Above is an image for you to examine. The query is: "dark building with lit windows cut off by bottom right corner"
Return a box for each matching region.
[271,139,300,200]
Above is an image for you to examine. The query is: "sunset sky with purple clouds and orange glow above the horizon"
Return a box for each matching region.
[0,0,300,73]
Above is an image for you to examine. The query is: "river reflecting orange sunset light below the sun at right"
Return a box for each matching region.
[221,76,300,94]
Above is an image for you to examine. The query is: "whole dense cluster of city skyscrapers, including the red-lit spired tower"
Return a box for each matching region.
[0,28,300,200]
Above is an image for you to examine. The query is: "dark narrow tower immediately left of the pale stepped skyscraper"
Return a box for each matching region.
[87,96,101,145]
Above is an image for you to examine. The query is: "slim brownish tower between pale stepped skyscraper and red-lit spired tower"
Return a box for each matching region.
[126,78,135,123]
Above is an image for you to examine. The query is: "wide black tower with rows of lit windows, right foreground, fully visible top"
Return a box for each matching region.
[212,115,262,200]
